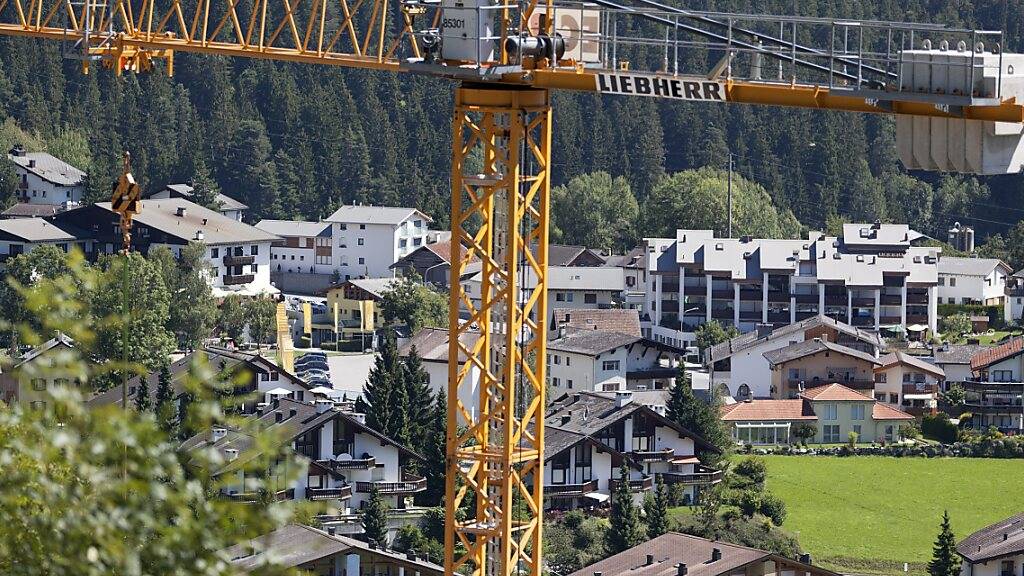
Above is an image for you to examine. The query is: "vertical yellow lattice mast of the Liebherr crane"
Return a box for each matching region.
[444,86,551,576]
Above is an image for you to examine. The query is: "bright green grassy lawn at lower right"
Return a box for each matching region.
[764,456,1024,574]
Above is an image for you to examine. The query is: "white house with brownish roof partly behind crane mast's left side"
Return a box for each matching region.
[398,328,480,419]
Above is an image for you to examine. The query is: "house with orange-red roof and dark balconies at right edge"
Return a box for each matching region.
[961,336,1024,434]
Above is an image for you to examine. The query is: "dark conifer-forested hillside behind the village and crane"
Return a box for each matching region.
[0,0,1024,255]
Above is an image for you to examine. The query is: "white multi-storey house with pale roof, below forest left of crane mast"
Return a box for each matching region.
[325,205,432,280]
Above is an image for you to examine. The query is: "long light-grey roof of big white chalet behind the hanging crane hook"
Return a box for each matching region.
[89,198,281,246]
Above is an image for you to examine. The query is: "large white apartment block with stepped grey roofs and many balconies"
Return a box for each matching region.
[644,222,939,347]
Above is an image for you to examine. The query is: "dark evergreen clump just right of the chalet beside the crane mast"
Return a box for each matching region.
[665,365,732,466]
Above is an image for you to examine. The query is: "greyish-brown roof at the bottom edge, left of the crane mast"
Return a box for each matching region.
[224,524,444,576]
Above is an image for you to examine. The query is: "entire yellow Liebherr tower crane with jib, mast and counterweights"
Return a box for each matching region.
[0,0,1024,576]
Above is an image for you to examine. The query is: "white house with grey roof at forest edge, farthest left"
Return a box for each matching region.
[7,146,86,208]
